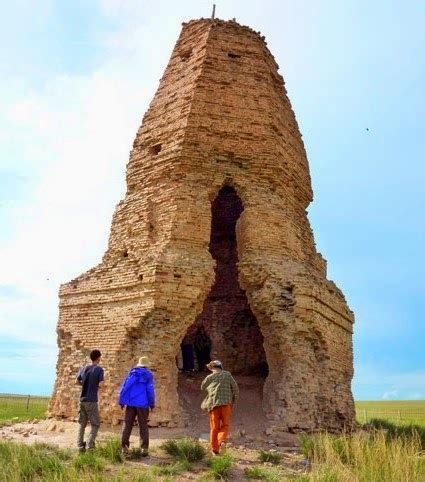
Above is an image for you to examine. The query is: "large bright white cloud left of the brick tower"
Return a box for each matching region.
[0,4,172,345]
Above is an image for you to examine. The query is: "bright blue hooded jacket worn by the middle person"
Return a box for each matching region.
[119,367,155,408]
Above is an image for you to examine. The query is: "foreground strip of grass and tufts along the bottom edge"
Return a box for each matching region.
[0,430,425,482]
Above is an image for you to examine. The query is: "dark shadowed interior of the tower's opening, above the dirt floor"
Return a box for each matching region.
[181,186,267,377]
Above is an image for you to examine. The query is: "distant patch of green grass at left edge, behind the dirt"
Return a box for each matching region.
[0,395,49,426]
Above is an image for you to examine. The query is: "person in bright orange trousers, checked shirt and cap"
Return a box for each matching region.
[201,360,239,455]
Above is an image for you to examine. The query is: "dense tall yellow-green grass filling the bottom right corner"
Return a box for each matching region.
[300,430,425,482]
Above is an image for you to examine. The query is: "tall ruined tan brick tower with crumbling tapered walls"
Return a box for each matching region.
[50,19,354,431]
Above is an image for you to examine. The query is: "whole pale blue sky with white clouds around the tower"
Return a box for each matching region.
[0,0,425,399]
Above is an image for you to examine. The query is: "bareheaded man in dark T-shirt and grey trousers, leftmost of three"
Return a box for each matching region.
[77,350,104,452]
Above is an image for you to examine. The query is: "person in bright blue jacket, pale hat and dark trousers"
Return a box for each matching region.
[119,356,155,457]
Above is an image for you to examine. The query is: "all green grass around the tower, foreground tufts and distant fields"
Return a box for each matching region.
[0,396,425,482]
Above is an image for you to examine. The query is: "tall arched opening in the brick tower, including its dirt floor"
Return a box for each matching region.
[178,186,268,432]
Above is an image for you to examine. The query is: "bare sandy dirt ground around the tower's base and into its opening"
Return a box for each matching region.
[0,374,305,481]
